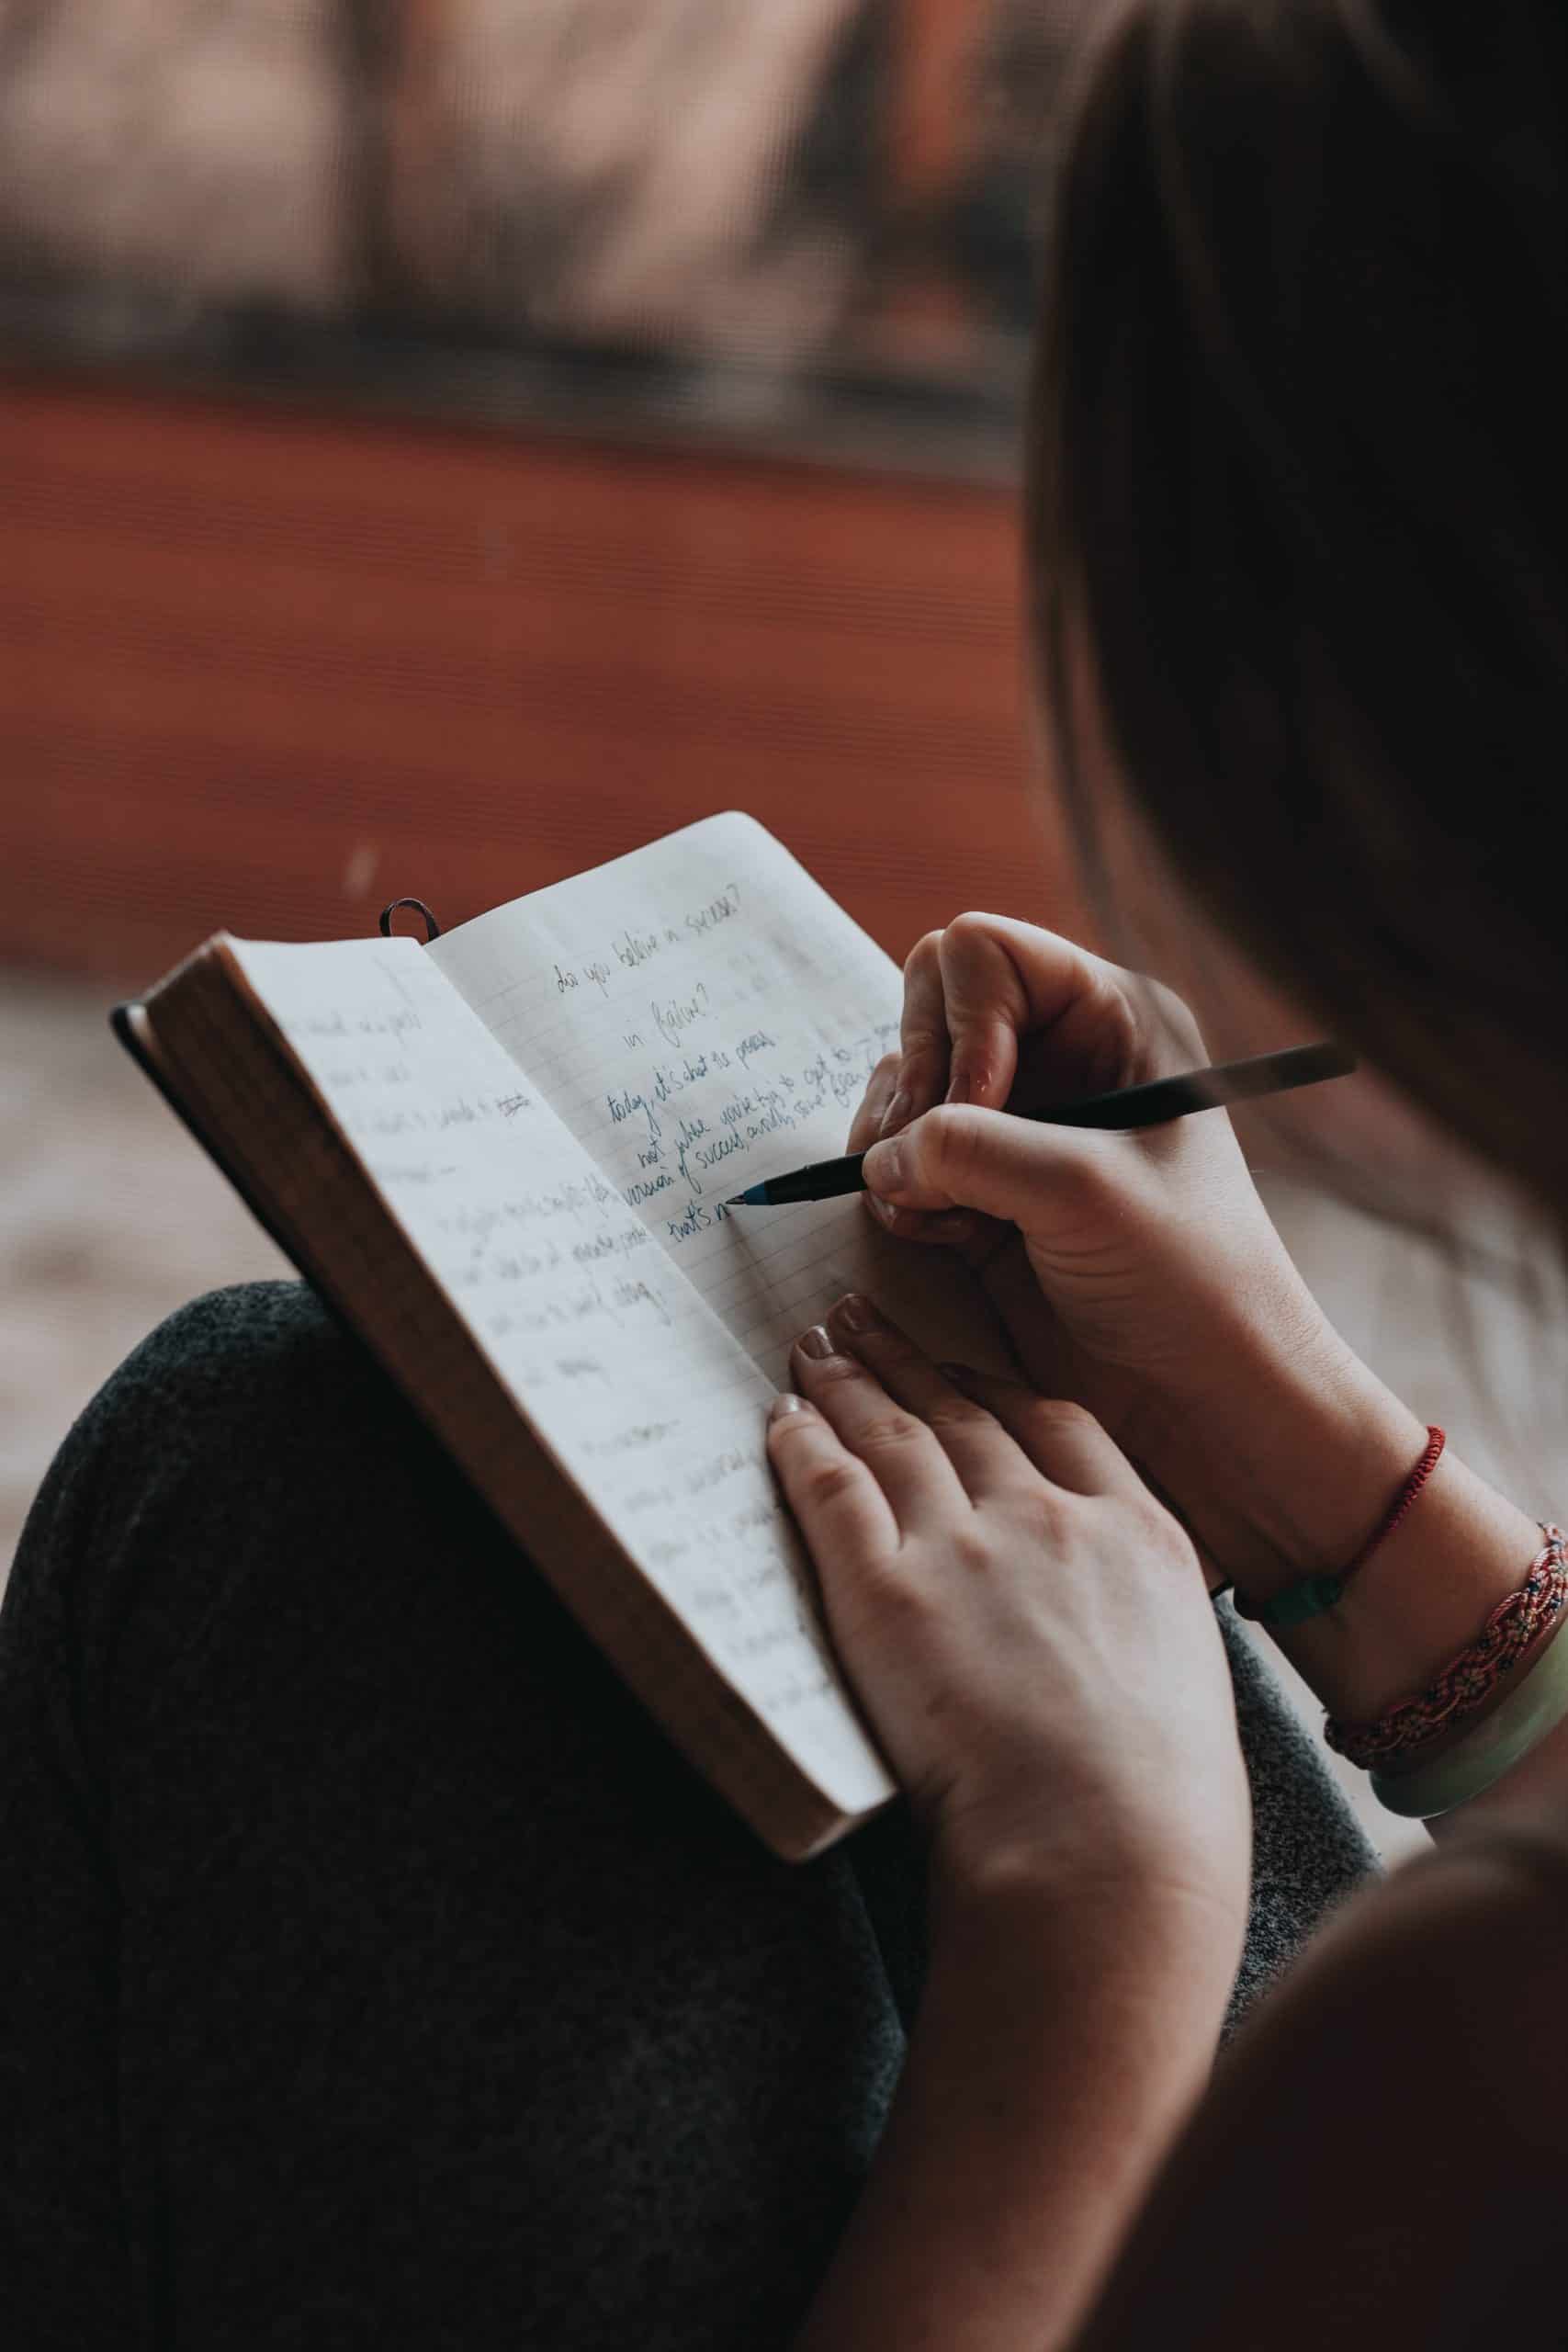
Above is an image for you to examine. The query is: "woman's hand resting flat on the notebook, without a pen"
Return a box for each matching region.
[769,1298,1251,1954]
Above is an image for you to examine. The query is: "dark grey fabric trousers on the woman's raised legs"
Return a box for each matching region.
[0,1282,1375,2352]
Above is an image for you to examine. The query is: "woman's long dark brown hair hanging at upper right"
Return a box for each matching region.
[1027,0,1568,1218]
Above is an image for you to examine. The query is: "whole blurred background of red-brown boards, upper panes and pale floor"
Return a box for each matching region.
[0,0,1568,1871]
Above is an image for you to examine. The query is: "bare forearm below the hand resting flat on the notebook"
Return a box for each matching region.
[797,1882,1239,2352]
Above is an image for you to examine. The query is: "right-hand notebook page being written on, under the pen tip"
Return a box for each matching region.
[428,814,1009,1387]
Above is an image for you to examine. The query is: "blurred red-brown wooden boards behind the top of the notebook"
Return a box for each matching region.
[0,379,1069,981]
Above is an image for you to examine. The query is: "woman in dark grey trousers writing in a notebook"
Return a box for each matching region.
[0,0,1568,2352]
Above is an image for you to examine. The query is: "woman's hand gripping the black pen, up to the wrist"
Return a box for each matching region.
[849,915,1422,1580]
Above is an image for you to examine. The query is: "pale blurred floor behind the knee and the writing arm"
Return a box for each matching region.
[0,974,1568,1860]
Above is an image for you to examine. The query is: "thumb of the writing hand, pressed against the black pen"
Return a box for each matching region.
[865,1103,1122,1232]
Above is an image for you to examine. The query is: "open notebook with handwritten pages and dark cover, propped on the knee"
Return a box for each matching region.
[115,814,1006,1858]
